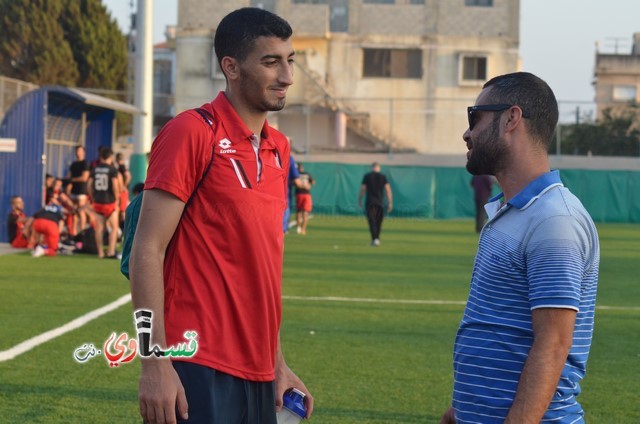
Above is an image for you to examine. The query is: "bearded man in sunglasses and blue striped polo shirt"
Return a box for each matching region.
[442,72,600,424]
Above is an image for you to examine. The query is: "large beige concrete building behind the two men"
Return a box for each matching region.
[175,0,520,154]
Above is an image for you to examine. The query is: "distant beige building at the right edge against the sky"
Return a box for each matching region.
[594,32,640,118]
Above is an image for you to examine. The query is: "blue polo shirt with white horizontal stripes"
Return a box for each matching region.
[453,171,600,423]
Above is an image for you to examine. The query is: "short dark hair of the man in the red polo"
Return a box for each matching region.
[213,7,293,70]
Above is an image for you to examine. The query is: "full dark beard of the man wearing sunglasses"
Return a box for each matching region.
[467,116,509,175]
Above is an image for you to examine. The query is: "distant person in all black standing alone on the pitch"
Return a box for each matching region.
[358,162,393,246]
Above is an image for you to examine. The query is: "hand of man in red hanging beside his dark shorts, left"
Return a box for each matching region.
[138,358,188,424]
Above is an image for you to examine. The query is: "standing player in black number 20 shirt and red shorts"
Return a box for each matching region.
[89,147,120,258]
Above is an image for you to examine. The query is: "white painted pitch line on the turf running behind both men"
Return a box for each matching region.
[0,294,640,362]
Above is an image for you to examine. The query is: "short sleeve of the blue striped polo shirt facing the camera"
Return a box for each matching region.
[526,215,593,311]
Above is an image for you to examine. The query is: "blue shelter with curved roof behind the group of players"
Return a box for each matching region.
[0,86,141,242]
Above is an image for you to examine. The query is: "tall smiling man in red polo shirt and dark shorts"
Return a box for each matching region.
[131,8,313,424]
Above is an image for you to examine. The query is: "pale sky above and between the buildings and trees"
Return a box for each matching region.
[102,0,640,122]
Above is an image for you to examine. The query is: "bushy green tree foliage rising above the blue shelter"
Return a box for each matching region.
[0,0,127,90]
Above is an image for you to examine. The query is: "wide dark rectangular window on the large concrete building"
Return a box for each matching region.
[362,49,422,79]
